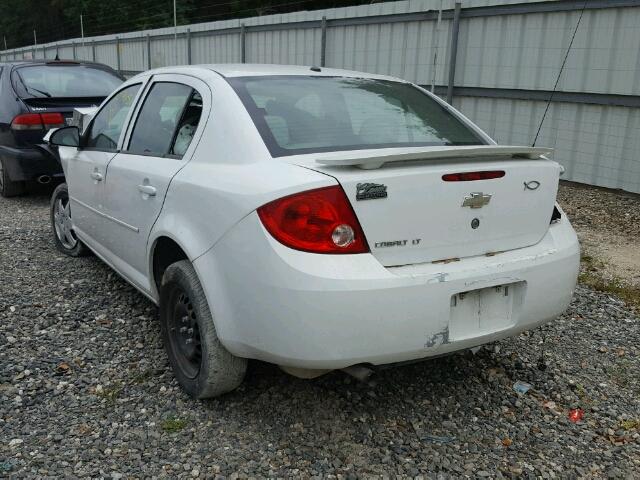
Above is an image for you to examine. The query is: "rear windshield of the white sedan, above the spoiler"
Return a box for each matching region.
[229,76,484,157]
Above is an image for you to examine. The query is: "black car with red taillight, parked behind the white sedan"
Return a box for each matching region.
[0,60,123,197]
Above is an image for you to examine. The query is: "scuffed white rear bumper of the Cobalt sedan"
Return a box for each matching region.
[194,213,580,369]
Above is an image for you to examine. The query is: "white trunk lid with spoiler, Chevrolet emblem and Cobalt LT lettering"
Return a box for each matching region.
[289,145,561,266]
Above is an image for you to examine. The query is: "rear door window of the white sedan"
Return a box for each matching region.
[127,82,202,158]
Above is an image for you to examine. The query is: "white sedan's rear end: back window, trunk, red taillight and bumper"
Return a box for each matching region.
[195,72,579,369]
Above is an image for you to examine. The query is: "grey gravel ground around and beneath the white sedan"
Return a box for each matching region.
[0,186,640,478]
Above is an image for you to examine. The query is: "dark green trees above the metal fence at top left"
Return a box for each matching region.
[0,0,373,50]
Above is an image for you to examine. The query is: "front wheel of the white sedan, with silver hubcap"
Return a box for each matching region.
[50,183,91,257]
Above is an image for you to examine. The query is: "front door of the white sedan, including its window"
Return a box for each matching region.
[65,83,142,244]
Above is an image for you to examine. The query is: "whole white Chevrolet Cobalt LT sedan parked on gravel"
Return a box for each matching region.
[48,65,579,398]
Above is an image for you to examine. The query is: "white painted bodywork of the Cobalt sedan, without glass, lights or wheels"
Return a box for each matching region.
[53,65,579,376]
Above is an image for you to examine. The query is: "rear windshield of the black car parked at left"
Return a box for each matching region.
[13,65,122,98]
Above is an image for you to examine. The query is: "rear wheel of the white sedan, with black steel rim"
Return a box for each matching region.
[160,260,247,399]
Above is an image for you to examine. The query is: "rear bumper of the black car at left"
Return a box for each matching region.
[0,145,64,182]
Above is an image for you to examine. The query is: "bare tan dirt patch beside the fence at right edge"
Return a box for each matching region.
[558,182,640,308]
